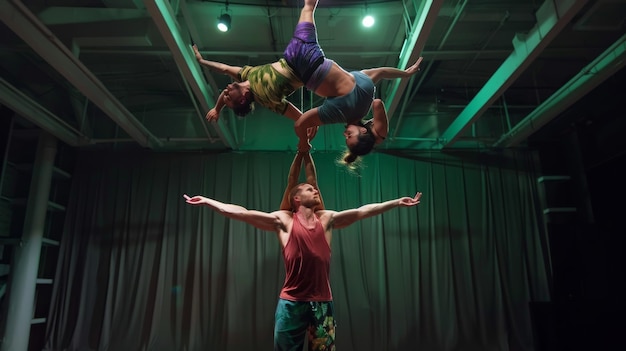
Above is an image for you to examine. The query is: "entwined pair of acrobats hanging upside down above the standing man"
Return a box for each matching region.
[194,0,422,163]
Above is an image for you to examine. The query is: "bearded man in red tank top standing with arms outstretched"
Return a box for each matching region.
[184,151,422,351]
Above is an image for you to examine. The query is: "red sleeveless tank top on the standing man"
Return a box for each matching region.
[280,213,333,301]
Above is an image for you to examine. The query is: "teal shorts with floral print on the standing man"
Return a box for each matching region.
[274,299,335,351]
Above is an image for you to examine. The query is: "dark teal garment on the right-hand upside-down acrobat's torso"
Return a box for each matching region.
[317,71,376,124]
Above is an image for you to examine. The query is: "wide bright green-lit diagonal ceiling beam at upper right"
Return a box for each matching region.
[436,0,587,148]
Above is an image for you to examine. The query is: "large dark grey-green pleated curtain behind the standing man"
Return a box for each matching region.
[46,151,550,351]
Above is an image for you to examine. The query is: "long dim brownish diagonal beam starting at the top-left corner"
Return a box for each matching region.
[0,0,161,148]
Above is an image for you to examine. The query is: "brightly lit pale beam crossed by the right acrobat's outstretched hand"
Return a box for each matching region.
[385,0,444,116]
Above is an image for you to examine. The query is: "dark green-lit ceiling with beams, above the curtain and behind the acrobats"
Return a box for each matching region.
[0,0,626,152]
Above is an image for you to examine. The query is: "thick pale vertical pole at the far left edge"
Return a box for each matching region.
[0,132,57,351]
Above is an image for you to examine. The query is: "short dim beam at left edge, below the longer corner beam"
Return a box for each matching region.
[0,78,89,146]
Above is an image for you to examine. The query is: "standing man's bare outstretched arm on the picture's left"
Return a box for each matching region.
[183,194,286,232]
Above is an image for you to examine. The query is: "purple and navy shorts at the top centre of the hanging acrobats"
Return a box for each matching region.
[283,22,333,91]
